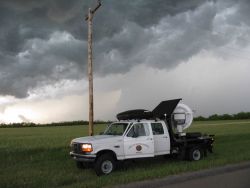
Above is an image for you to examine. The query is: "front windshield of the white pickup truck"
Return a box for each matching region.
[103,123,128,136]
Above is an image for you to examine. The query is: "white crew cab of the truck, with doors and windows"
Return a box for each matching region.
[103,120,170,159]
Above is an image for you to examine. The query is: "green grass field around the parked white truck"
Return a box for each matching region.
[0,120,250,188]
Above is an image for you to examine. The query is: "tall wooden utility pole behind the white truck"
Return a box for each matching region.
[85,0,101,136]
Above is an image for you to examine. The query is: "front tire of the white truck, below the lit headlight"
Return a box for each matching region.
[95,153,116,176]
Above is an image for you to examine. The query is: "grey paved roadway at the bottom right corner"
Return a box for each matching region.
[119,162,250,188]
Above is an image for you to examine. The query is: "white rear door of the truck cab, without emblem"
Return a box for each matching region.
[151,122,170,155]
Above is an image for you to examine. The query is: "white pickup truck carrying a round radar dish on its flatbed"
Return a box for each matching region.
[70,99,214,175]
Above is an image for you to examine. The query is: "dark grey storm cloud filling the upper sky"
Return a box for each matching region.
[0,0,250,98]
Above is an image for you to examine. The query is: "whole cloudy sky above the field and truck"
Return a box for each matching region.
[0,0,250,123]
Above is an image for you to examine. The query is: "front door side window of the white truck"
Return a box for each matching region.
[127,123,149,137]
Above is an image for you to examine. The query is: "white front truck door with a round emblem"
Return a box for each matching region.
[124,122,154,159]
